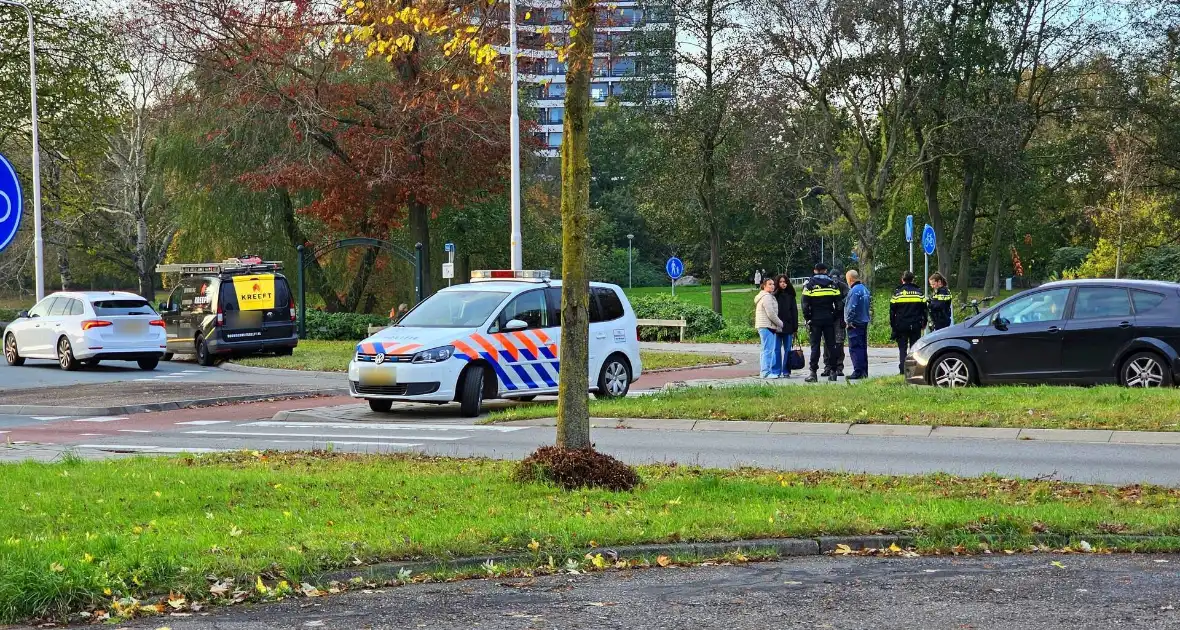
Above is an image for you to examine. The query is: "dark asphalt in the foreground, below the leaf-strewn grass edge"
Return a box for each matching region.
[112,554,1180,630]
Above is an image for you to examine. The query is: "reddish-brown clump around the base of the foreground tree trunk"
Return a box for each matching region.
[513,446,641,492]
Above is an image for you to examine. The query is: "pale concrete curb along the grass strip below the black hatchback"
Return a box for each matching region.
[494,418,1180,446]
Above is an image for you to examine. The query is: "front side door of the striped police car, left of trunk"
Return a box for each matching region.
[489,289,557,396]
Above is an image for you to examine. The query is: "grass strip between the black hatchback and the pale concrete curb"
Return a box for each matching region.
[490,376,1180,431]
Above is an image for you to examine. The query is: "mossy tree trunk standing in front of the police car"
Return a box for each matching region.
[557,0,595,448]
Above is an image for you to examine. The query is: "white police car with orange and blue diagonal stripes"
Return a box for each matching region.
[348,270,642,416]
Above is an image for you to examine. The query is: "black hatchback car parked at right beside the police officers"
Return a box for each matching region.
[905,280,1180,387]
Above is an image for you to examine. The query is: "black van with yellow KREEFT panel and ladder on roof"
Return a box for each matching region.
[156,261,299,366]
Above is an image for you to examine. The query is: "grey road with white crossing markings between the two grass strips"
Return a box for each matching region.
[0,401,1180,486]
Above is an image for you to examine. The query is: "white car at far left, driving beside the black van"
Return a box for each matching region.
[4,291,168,370]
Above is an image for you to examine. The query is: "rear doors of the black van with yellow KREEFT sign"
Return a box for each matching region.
[218,274,295,341]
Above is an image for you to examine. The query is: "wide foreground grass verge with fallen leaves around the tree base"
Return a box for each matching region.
[0,452,1180,622]
